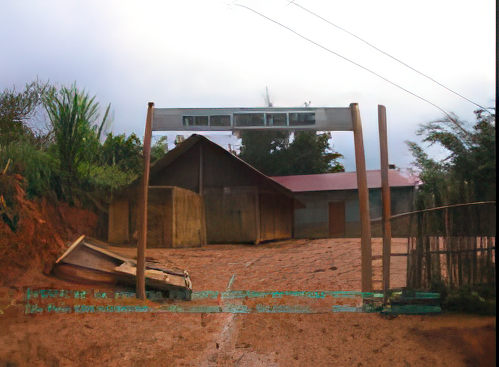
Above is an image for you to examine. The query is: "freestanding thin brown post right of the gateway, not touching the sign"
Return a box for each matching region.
[378,105,392,305]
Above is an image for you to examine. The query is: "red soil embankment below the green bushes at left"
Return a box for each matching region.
[0,175,97,285]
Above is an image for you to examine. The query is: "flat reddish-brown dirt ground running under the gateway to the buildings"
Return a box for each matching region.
[0,239,496,367]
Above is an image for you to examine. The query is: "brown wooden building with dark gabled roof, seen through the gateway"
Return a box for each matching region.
[109,134,294,247]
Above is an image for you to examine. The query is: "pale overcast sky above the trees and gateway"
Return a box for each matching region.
[0,0,496,171]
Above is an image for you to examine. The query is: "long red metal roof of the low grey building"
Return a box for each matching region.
[271,170,418,192]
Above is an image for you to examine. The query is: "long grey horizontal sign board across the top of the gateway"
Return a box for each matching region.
[152,107,353,131]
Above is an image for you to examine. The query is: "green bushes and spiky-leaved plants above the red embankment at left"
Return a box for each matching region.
[0,81,172,211]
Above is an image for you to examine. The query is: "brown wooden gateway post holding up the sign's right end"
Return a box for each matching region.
[350,103,373,292]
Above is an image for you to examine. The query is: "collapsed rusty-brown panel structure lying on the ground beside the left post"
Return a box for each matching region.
[53,236,192,299]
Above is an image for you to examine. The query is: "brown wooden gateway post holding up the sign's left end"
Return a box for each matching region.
[136,102,154,300]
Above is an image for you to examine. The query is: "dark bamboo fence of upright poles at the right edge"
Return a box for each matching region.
[391,202,496,290]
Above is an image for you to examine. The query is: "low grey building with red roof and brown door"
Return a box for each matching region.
[272,169,418,238]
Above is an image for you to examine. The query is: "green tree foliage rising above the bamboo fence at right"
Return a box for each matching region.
[406,110,496,208]
